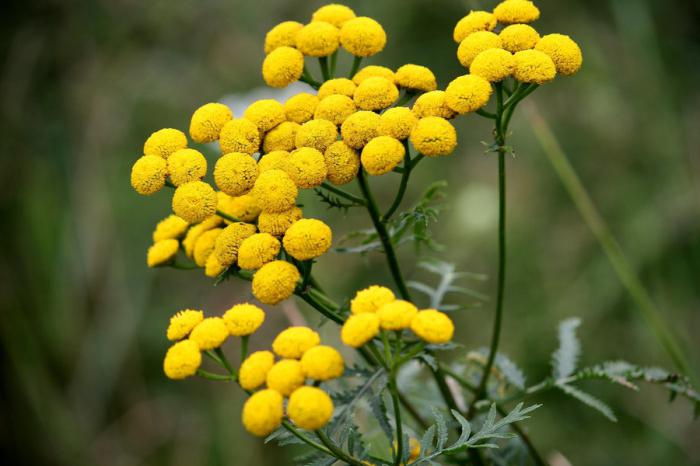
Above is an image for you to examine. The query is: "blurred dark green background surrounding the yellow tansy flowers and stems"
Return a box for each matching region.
[0,0,700,465]
